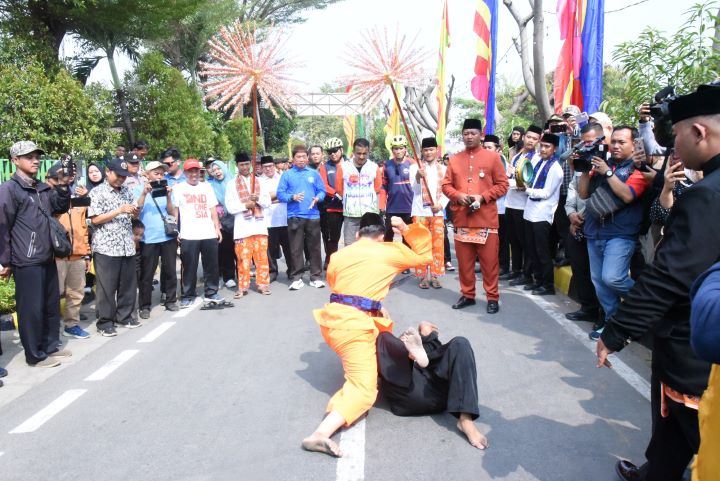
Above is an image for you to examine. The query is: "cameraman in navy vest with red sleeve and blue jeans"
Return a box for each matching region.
[576,125,648,340]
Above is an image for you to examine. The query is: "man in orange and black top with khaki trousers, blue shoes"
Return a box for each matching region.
[46,156,90,339]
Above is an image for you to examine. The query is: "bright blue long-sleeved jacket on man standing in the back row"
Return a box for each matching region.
[277,166,325,219]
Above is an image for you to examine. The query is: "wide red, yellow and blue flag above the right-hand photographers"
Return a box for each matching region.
[554,0,605,113]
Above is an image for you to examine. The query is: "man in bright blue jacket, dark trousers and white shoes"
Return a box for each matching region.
[277,145,325,291]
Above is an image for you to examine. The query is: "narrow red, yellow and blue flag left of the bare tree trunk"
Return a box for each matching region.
[470,0,498,134]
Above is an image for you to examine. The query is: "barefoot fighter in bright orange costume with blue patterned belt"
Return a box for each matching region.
[302,212,432,457]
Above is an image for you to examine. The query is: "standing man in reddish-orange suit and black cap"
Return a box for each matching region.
[442,119,509,314]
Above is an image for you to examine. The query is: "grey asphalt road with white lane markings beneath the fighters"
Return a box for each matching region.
[0,260,650,481]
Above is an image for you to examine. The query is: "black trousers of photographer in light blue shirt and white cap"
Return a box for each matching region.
[138,239,177,309]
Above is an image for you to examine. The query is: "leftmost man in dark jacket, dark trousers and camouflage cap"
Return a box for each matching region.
[0,141,70,367]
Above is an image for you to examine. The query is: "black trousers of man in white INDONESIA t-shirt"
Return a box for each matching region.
[180,237,220,299]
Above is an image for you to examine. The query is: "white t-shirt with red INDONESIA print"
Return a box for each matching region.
[172,182,217,240]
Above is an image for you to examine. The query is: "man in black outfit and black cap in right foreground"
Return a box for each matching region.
[597,86,720,481]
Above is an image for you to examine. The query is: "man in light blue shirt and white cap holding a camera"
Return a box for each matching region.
[134,161,179,319]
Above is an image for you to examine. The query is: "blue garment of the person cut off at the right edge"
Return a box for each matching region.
[690,262,720,364]
